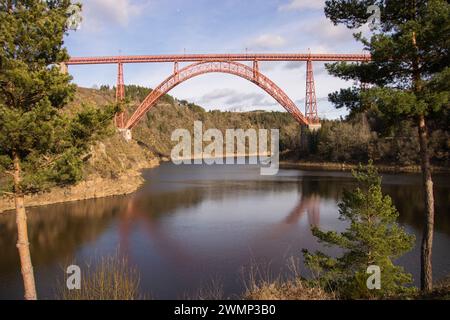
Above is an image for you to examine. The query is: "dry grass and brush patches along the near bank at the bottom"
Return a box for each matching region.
[56,254,450,301]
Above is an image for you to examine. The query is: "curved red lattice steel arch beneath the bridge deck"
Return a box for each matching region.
[122,61,310,129]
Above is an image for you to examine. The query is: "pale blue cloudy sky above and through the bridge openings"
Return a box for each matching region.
[66,0,370,118]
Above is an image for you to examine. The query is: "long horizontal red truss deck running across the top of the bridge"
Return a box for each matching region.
[66,53,370,65]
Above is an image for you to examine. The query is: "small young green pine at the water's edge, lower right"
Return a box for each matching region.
[303,163,414,299]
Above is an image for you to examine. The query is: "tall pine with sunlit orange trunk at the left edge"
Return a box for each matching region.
[0,0,116,299]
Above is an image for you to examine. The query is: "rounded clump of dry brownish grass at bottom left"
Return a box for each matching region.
[57,255,144,300]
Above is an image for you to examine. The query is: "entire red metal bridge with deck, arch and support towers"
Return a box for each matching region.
[64,53,371,129]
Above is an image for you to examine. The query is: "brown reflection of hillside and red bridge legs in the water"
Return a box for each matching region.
[0,175,450,278]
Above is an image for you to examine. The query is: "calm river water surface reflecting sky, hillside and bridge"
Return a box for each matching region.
[0,163,450,299]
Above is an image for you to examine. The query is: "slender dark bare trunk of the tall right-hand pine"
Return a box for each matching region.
[419,115,434,292]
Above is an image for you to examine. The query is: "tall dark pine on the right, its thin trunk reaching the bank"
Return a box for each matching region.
[325,0,450,291]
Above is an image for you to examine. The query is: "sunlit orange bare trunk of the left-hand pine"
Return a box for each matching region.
[14,154,37,300]
